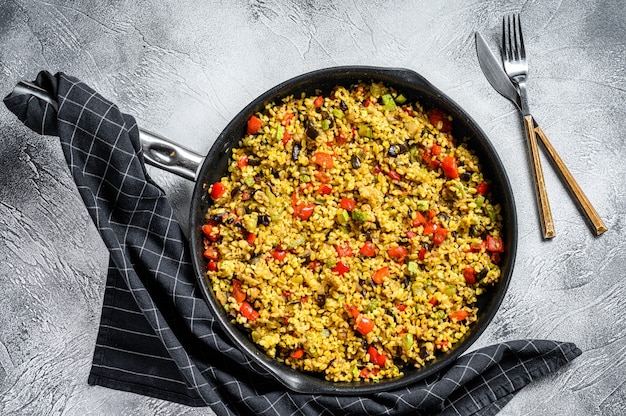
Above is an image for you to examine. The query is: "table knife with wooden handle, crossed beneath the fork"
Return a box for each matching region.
[476,32,608,235]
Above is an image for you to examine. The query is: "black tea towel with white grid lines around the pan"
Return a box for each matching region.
[4,71,581,416]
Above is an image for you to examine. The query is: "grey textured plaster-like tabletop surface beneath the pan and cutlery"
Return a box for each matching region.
[0,0,626,415]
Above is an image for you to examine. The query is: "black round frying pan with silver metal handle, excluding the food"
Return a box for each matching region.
[14,66,517,395]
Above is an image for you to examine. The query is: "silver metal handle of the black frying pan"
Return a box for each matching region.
[10,81,204,181]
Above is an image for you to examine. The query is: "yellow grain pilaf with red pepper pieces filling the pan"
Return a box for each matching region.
[203,83,504,382]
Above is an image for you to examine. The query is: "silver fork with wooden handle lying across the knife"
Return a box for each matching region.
[502,14,556,239]
